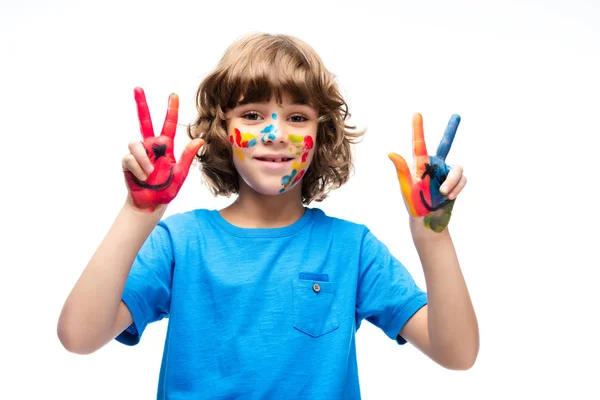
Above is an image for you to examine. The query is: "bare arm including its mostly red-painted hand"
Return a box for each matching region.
[57,88,204,354]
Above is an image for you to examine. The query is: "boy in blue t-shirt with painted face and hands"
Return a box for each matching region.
[58,35,478,399]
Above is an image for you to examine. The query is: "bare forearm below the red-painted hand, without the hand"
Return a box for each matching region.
[58,205,165,352]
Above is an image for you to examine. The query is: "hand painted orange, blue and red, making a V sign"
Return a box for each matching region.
[388,114,467,233]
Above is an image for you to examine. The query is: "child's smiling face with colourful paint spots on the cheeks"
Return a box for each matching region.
[225,97,318,195]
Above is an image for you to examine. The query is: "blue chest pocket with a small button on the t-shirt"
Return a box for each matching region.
[292,279,339,337]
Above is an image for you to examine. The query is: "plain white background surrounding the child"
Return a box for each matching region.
[0,0,600,400]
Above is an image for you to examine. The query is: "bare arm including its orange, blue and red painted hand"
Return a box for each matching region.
[390,114,479,369]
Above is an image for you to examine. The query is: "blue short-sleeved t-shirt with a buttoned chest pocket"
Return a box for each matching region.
[116,208,427,400]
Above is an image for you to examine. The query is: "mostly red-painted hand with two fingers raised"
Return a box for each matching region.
[122,88,204,212]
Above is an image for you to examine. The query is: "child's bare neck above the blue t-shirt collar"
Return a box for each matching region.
[219,181,304,228]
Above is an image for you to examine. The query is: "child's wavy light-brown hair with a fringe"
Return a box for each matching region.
[187,34,365,205]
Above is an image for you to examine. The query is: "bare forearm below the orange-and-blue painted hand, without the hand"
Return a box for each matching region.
[411,221,479,369]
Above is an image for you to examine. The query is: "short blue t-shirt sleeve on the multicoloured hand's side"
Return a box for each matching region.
[356,230,427,344]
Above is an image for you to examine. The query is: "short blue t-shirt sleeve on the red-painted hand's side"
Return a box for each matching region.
[116,221,174,346]
